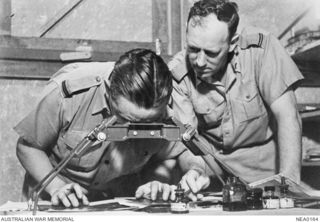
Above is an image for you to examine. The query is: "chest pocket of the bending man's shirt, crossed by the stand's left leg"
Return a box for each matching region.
[59,130,104,172]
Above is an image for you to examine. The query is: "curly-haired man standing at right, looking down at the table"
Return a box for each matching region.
[136,0,303,200]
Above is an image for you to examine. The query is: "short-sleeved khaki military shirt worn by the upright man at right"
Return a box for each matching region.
[169,28,303,181]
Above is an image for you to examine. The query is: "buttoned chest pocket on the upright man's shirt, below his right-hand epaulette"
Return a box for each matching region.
[233,81,266,122]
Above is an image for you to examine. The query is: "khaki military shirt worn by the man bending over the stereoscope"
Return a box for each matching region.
[15,62,184,196]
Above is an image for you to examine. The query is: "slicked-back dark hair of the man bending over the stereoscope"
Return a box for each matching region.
[110,49,172,109]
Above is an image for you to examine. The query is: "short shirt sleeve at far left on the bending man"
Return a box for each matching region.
[14,82,62,150]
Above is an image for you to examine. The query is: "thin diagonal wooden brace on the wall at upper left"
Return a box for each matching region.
[39,0,84,37]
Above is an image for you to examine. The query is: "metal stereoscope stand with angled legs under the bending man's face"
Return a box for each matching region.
[28,116,246,215]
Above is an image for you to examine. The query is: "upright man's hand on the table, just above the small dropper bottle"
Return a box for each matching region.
[180,170,210,201]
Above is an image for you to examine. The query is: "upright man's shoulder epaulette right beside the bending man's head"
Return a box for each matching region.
[168,51,188,83]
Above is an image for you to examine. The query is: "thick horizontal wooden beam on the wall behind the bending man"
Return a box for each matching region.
[0,36,169,79]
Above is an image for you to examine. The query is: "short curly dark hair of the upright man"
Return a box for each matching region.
[188,0,239,39]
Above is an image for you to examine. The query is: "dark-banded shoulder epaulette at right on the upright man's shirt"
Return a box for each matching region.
[239,33,266,49]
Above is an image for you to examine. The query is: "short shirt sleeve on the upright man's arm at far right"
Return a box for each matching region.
[257,35,303,105]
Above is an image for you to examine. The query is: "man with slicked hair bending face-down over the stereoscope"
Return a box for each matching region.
[15,49,204,207]
